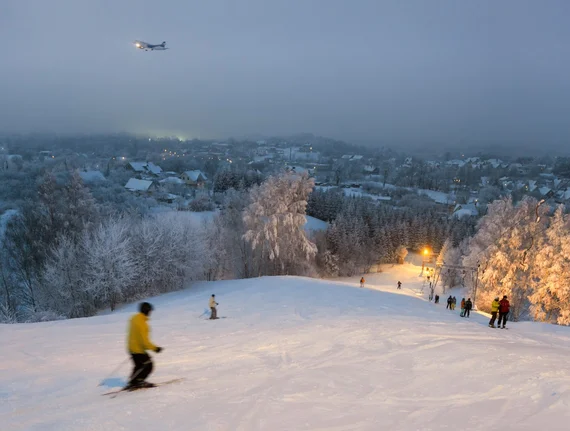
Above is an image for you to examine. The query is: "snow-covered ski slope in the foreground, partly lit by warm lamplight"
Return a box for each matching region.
[0,264,570,431]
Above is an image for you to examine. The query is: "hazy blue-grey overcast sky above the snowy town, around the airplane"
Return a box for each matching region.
[0,0,570,145]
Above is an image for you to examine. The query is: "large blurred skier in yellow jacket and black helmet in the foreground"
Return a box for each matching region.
[126,302,162,389]
